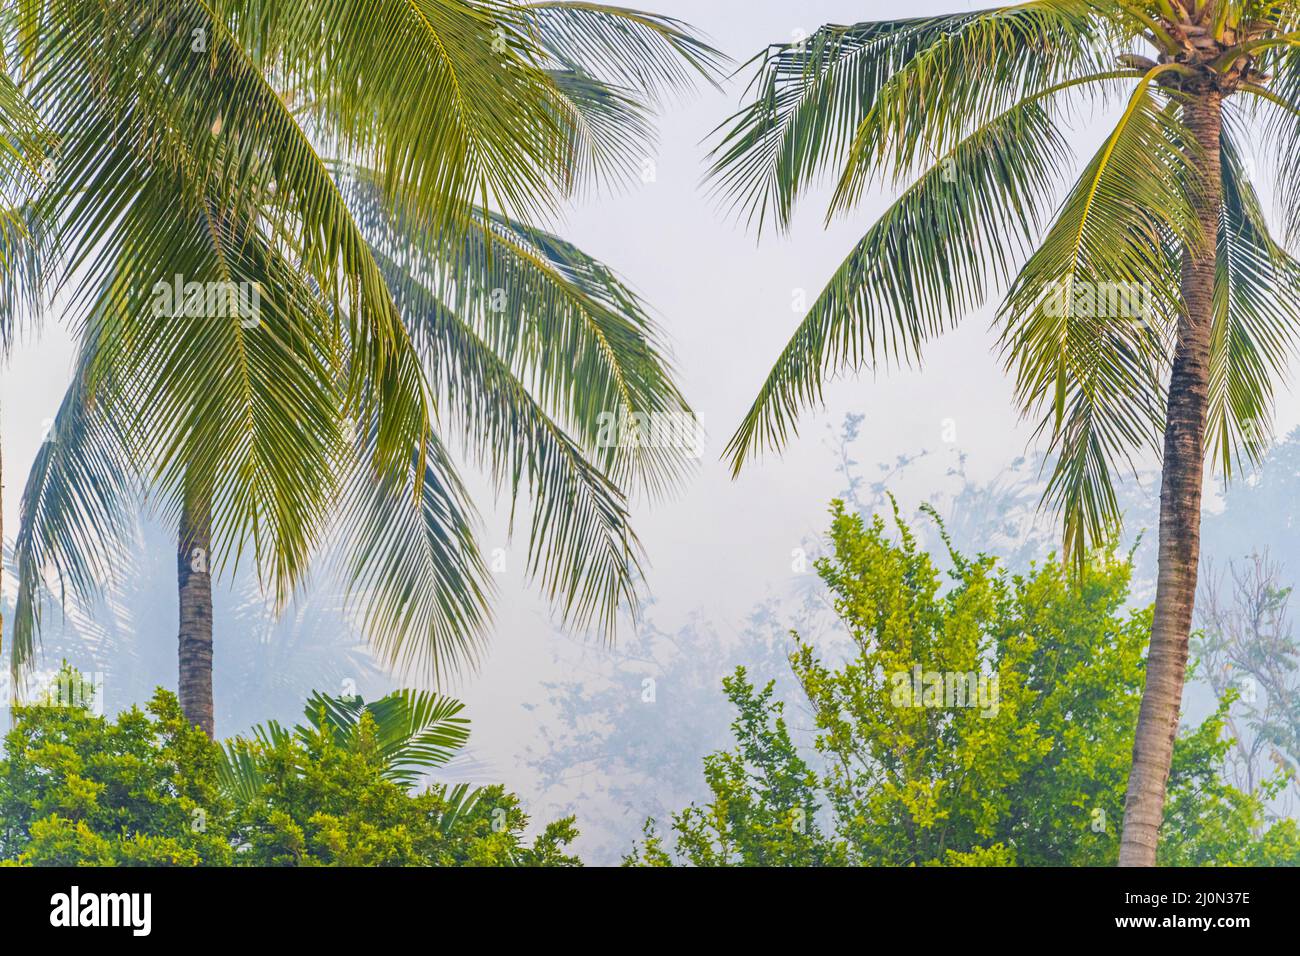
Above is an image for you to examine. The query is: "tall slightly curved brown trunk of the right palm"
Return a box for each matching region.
[1119,90,1222,866]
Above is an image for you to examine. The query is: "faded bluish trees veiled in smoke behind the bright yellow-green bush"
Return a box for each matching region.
[528,415,1300,862]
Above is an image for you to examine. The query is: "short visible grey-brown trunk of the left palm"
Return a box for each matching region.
[176,492,215,737]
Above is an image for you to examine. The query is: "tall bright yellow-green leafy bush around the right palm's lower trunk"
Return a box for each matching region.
[628,502,1300,866]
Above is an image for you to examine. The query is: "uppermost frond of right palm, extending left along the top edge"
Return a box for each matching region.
[710,0,1100,234]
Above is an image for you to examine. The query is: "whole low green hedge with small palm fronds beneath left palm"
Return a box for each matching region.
[0,671,579,866]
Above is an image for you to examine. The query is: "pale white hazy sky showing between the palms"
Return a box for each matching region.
[10,0,1300,858]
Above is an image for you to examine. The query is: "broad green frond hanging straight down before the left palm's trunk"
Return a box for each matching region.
[81,167,345,606]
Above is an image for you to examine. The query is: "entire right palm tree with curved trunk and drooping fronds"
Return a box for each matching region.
[712,0,1300,865]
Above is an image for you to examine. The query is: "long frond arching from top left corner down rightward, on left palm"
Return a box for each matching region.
[25,0,429,494]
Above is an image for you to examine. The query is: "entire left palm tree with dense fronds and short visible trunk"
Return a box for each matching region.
[9,0,719,735]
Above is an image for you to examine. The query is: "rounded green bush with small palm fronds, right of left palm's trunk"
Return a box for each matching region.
[221,692,579,866]
